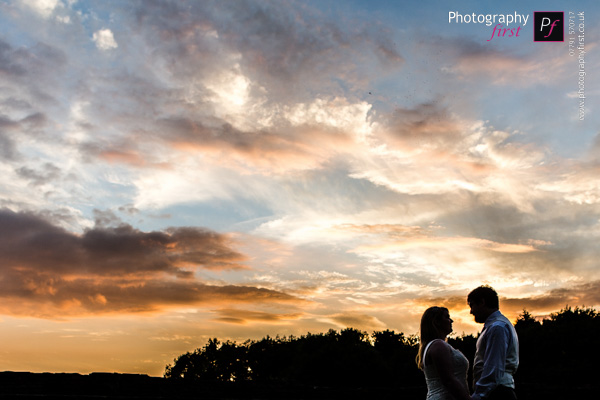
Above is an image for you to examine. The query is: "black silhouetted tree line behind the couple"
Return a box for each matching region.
[164,306,600,399]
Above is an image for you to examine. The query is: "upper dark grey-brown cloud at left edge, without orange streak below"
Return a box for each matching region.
[0,210,245,276]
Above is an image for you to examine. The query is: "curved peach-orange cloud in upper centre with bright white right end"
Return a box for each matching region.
[149,100,369,172]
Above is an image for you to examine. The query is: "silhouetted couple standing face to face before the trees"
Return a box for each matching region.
[416,286,519,400]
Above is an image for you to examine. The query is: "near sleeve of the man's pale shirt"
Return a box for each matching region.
[473,325,509,400]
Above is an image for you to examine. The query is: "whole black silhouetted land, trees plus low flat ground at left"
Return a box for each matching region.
[0,307,600,400]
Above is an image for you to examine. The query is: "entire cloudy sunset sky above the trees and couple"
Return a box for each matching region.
[0,0,600,376]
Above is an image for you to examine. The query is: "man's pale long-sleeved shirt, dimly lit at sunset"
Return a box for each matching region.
[473,311,519,400]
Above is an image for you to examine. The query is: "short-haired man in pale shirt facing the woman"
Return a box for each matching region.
[467,286,519,400]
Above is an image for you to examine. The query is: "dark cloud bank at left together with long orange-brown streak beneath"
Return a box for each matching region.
[0,209,295,317]
